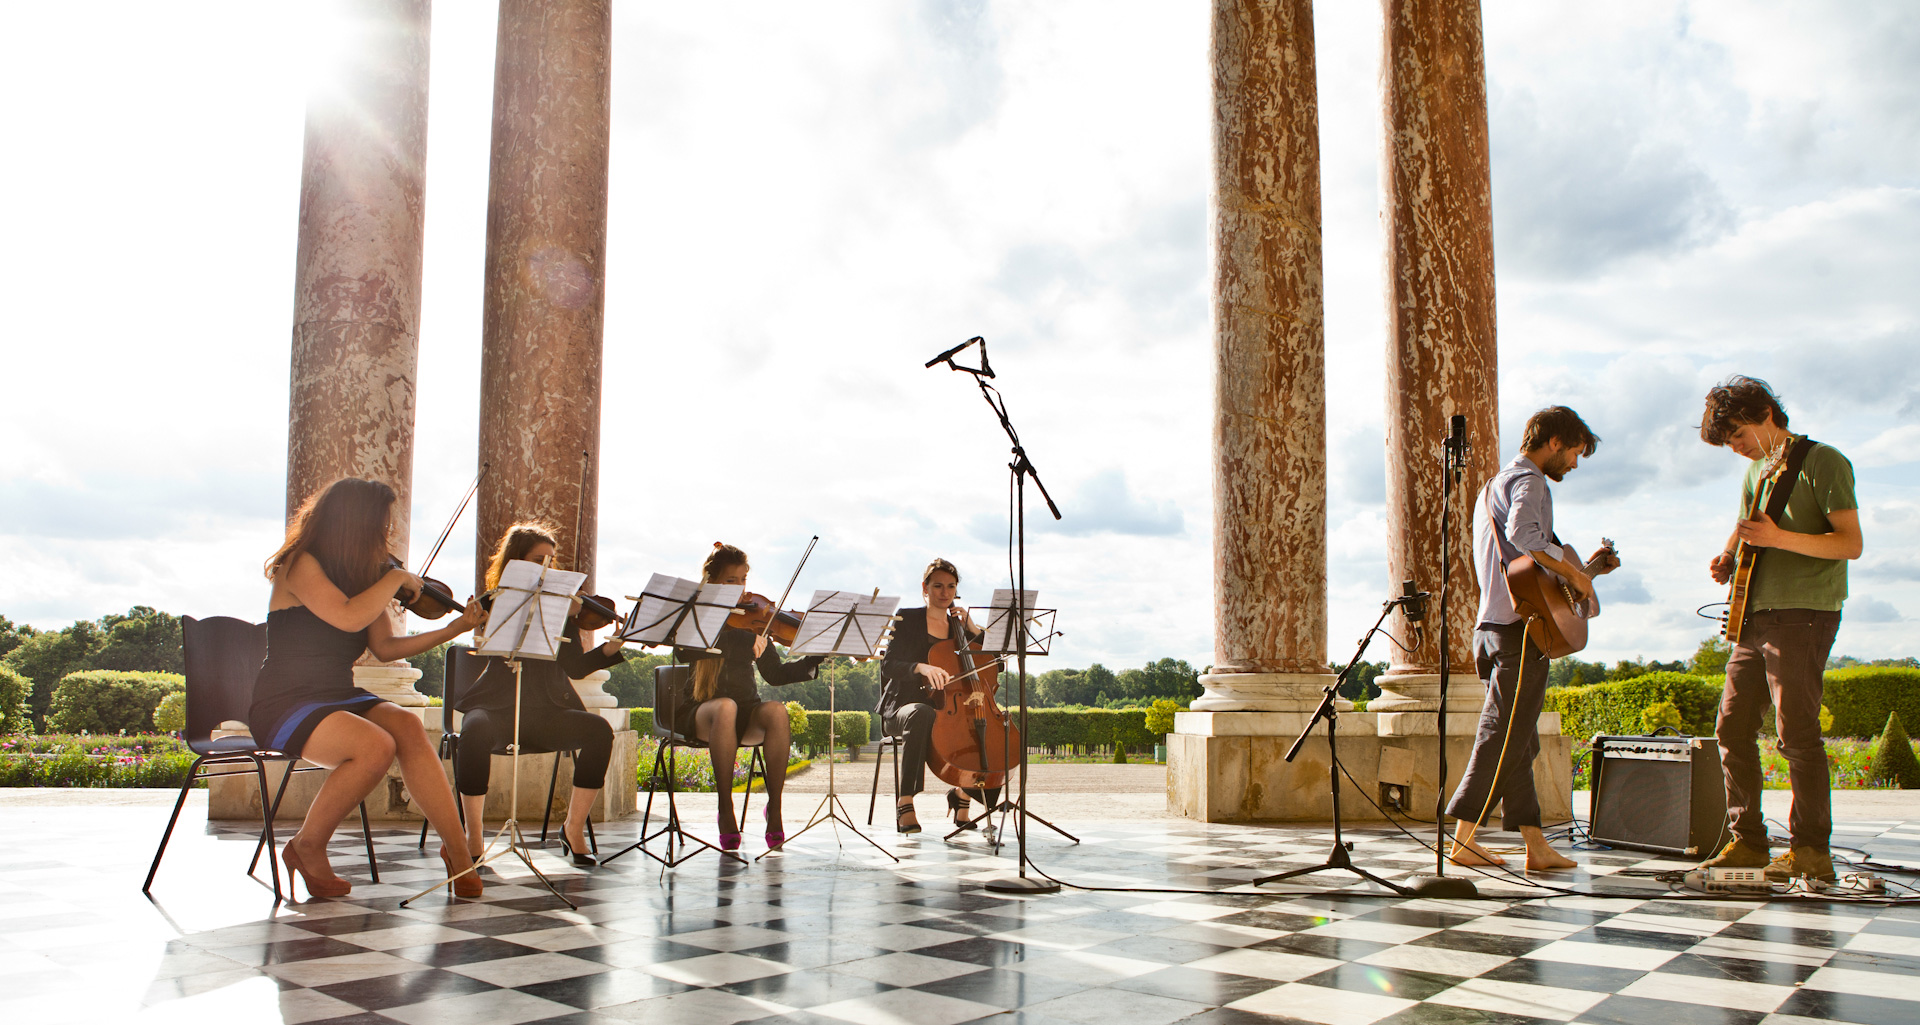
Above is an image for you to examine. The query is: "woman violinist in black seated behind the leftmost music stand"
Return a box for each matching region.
[453,522,626,868]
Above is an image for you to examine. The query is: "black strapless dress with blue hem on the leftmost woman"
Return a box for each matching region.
[246,605,384,754]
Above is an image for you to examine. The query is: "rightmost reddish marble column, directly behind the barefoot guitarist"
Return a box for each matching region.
[1369,0,1500,733]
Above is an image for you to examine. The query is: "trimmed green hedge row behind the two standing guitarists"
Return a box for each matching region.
[1546,666,1920,737]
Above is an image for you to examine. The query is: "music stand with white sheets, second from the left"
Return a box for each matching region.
[601,574,747,868]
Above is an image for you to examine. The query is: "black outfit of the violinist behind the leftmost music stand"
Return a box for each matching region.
[453,618,626,795]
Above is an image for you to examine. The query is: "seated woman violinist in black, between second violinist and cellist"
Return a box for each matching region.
[674,541,826,850]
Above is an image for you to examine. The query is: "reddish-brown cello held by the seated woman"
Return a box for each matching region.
[927,610,1027,797]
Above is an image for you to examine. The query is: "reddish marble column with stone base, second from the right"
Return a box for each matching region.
[1167,0,1344,820]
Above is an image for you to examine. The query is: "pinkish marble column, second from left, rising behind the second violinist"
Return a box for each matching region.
[476,0,612,587]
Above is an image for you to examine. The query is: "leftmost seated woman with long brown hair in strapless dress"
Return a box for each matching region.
[246,478,482,896]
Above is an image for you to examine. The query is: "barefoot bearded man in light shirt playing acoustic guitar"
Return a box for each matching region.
[1446,405,1620,871]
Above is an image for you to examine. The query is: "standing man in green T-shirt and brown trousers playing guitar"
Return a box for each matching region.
[1699,376,1862,883]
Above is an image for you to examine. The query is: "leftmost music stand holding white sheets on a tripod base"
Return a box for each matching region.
[399,555,586,910]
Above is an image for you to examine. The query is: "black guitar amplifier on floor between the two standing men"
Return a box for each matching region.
[1588,735,1726,858]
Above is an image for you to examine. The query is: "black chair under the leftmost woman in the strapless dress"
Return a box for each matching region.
[140,616,380,900]
